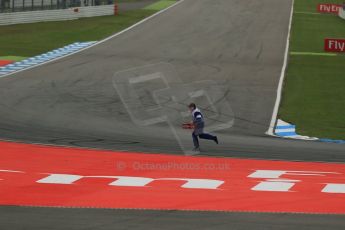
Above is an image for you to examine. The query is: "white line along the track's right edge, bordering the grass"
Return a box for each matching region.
[266,0,295,136]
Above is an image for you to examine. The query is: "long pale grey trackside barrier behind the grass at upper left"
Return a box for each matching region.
[0,5,114,25]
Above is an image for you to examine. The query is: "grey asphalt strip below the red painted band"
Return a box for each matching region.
[0,207,344,230]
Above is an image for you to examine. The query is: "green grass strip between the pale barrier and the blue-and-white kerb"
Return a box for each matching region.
[0,0,176,57]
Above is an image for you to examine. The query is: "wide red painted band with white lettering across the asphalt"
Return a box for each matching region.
[0,142,345,214]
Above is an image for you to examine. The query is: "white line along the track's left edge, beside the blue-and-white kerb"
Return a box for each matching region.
[0,0,185,78]
